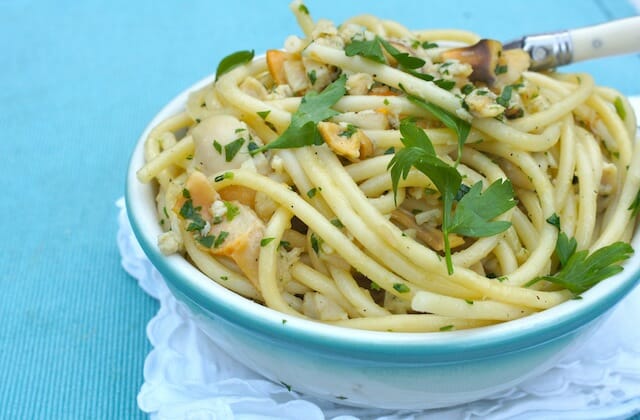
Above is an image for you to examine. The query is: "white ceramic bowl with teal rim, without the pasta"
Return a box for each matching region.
[126,73,640,409]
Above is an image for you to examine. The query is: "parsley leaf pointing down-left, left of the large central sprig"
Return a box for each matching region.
[251,74,347,154]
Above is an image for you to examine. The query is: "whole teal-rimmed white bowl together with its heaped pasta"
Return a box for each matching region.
[126,2,640,409]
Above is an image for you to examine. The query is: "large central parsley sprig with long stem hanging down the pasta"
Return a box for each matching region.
[388,120,516,274]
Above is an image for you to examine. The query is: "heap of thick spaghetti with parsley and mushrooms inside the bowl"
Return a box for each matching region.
[138,1,640,332]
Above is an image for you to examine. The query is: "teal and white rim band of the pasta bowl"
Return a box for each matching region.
[125,71,640,364]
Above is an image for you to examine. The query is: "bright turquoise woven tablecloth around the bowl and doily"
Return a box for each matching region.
[0,0,640,418]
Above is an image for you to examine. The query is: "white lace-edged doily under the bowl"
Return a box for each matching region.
[117,199,640,420]
